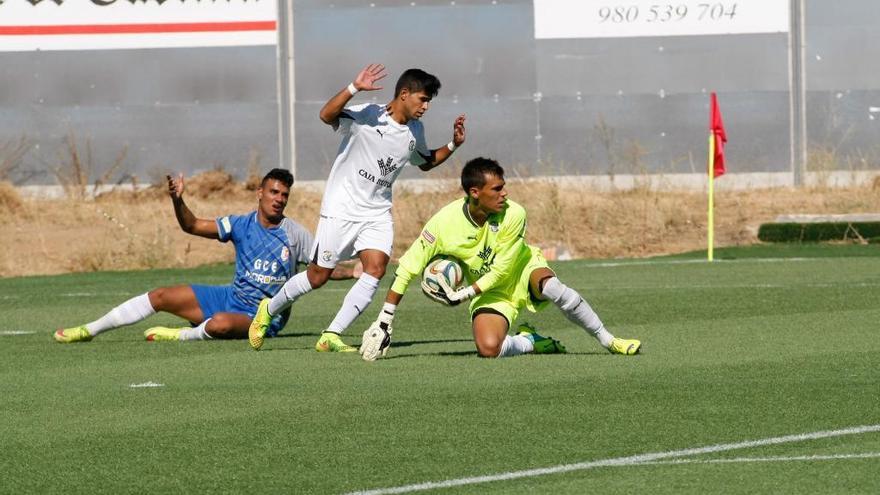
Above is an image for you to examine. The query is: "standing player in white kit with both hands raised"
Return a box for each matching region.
[248,64,465,352]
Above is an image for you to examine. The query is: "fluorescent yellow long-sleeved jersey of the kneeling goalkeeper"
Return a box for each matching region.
[391,198,531,294]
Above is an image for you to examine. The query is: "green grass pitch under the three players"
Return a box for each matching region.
[0,245,880,494]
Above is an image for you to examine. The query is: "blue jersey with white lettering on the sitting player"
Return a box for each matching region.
[217,212,314,308]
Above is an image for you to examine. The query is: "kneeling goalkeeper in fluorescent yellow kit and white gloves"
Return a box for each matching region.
[360,158,641,361]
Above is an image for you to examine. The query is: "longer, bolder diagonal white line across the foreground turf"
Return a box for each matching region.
[348,424,880,495]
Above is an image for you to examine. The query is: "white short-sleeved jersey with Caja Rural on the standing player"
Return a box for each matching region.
[321,103,430,221]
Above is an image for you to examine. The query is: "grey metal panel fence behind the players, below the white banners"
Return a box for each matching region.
[0,0,880,186]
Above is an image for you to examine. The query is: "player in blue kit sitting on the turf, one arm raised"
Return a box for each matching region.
[55,168,355,343]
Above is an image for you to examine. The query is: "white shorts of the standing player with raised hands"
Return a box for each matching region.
[311,216,394,268]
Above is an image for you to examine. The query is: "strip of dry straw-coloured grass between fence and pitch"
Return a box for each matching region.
[0,170,880,277]
